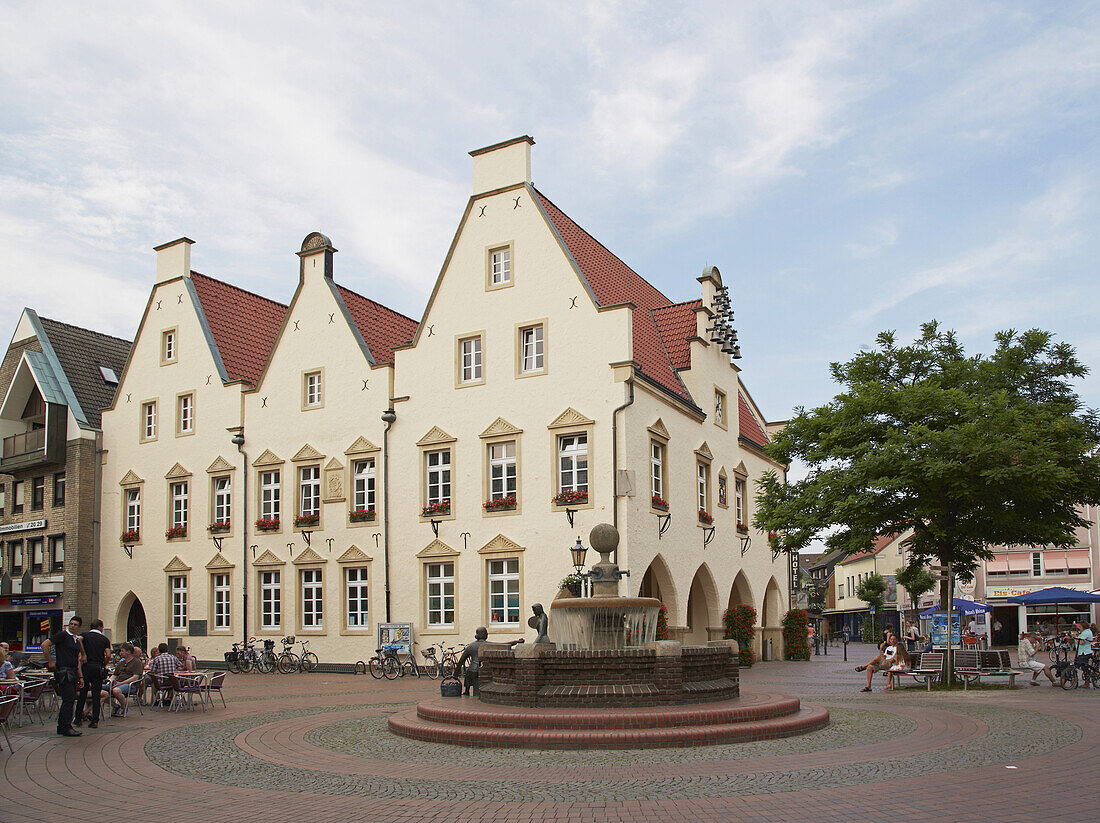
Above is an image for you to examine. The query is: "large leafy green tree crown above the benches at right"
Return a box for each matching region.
[754,321,1100,607]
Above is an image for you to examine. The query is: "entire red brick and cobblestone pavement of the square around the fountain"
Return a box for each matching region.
[0,646,1100,823]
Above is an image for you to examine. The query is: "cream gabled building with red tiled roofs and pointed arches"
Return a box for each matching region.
[96,138,798,662]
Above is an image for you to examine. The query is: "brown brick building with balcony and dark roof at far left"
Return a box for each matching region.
[0,308,130,651]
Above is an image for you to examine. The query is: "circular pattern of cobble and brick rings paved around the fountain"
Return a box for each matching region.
[145,698,1081,802]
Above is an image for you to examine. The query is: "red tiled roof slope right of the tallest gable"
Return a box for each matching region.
[532,187,697,408]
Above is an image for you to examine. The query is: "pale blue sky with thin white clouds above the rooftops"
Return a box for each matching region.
[0,0,1100,420]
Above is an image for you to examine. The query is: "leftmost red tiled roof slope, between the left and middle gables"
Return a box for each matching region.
[191,272,286,386]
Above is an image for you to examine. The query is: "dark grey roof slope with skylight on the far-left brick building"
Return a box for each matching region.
[39,317,131,429]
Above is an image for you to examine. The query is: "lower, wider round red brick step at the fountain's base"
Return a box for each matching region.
[389,707,828,749]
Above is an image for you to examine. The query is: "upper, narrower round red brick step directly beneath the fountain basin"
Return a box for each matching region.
[416,694,800,729]
